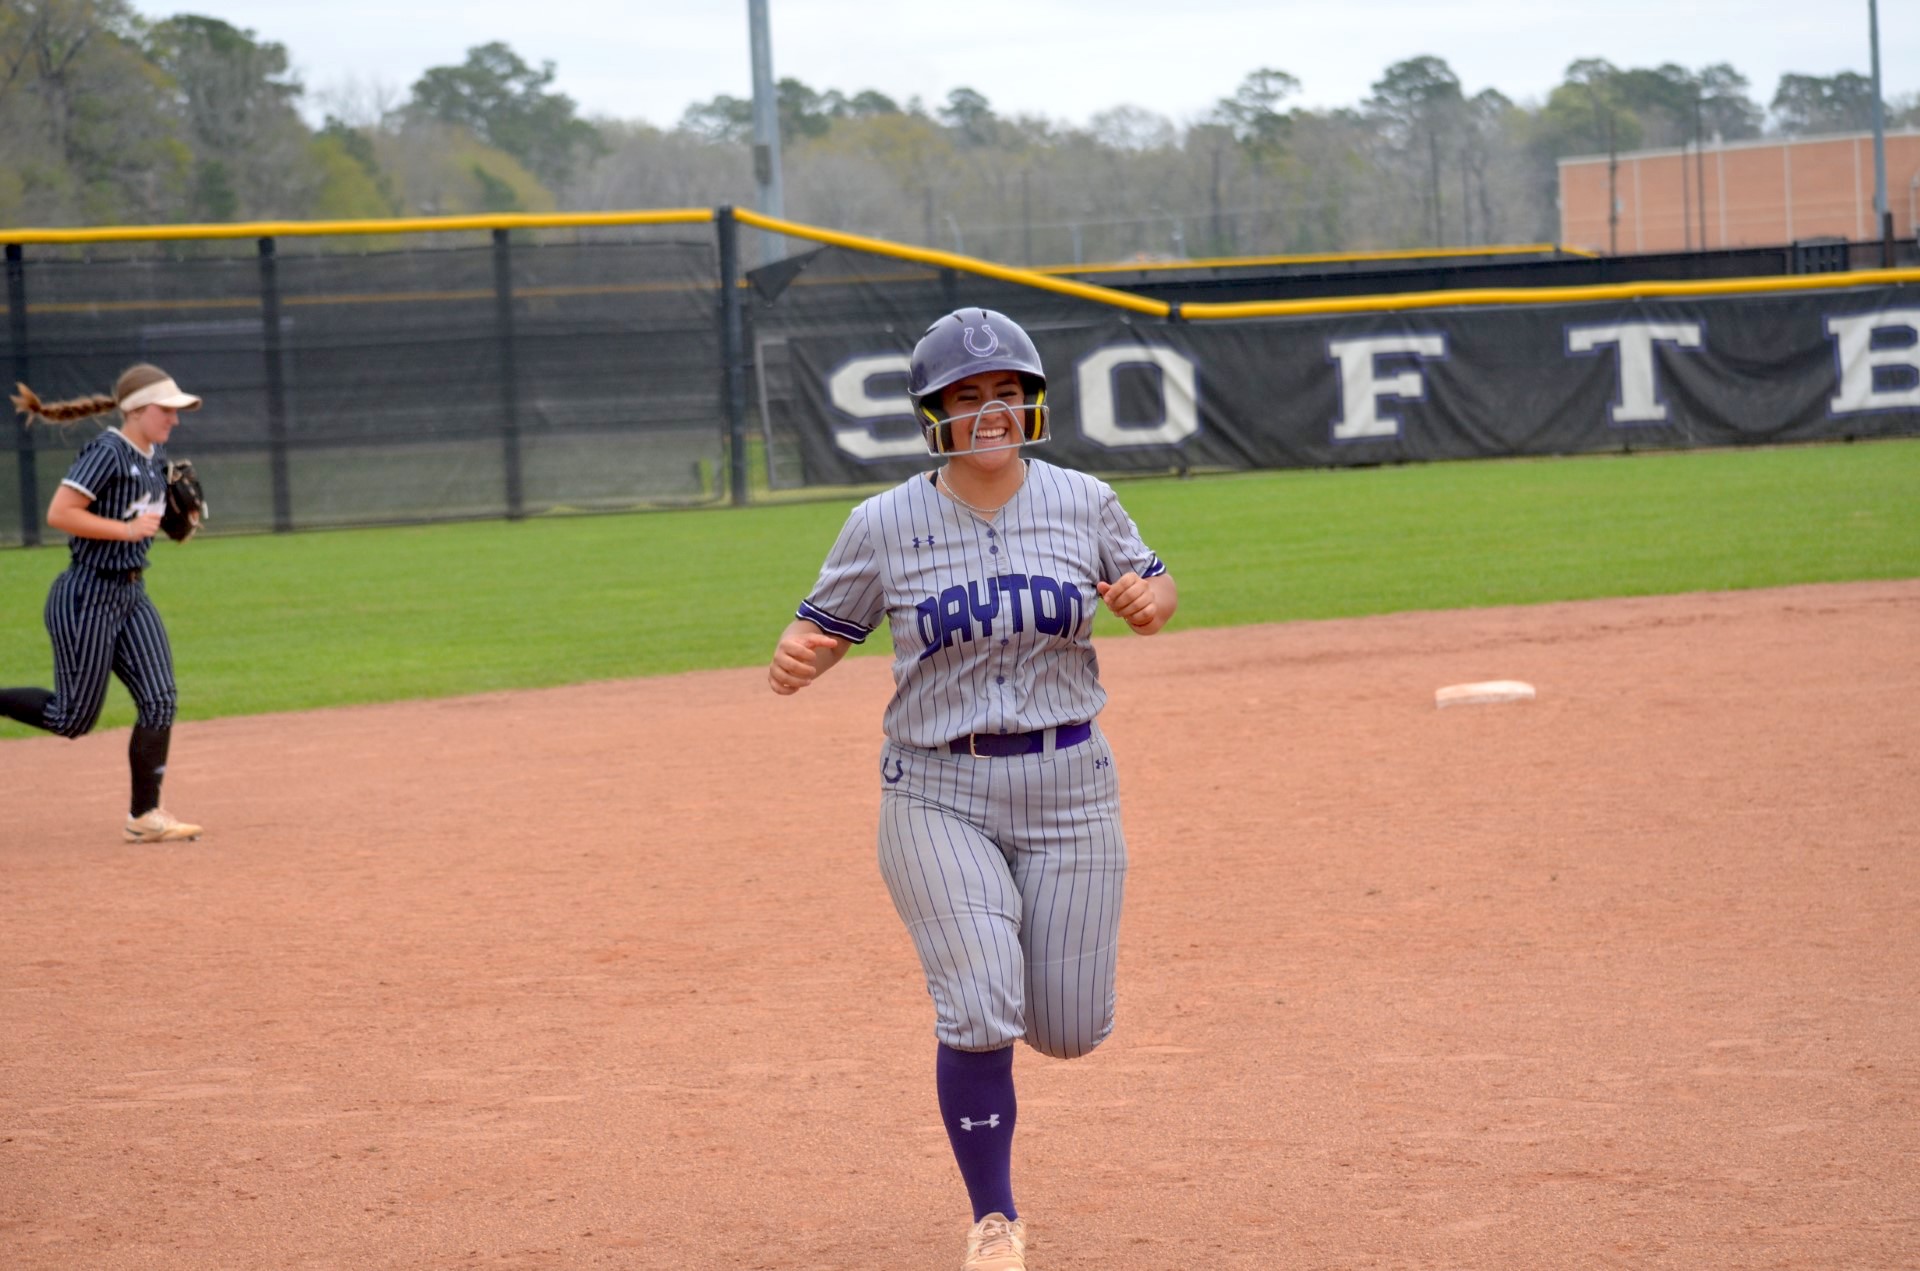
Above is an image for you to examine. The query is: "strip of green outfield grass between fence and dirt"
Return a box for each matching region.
[0,440,1920,737]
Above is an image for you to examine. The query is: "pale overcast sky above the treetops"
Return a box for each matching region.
[134,0,1920,127]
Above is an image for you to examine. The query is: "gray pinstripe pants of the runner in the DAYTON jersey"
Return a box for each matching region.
[879,728,1127,1060]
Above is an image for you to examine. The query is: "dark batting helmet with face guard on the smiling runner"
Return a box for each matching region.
[906,309,1052,455]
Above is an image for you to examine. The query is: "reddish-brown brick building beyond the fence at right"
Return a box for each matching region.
[1559,131,1920,255]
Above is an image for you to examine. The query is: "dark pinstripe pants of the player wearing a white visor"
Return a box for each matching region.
[44,566,179,737]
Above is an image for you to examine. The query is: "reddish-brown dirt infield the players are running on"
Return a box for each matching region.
[0,582,1920,1271]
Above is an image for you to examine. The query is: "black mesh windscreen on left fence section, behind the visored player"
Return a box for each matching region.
[0,227,726,543]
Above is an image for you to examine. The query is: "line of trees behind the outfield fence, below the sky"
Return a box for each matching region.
[0,0,1920,263]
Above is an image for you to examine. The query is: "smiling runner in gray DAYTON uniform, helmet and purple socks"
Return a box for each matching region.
[768,309,1177,1271]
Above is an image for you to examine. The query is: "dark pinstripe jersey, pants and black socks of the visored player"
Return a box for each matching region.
[0,428,177,816]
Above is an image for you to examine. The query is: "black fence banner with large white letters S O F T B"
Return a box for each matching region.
[760,286,1920,482]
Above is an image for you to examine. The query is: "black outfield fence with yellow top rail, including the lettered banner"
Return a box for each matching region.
[0,209,1920,543]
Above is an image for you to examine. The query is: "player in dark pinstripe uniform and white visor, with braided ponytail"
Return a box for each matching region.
[0,363,200,843]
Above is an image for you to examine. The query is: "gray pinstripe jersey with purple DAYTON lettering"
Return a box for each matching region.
[799,459,1165,747]
